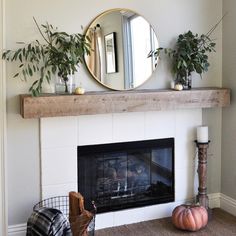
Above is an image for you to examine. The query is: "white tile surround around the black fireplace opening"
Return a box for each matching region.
[40,109,202,229]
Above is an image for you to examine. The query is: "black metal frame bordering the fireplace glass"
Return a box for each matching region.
[77,138,175,213]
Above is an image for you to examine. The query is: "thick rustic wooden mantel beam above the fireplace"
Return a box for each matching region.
[20,88,230,118]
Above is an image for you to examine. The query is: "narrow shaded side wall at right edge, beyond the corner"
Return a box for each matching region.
[221,0,236,199]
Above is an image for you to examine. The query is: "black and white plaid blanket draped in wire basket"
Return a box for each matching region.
[26,208,72,236]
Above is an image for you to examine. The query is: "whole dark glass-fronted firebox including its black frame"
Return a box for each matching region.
[78,138,174,213]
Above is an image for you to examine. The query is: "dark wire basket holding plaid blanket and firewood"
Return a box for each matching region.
[33,196,96,236]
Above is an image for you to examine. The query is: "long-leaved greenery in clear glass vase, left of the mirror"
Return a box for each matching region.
[2,18,91,96]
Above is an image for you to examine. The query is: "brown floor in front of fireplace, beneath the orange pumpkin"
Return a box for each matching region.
[95,208,236,236]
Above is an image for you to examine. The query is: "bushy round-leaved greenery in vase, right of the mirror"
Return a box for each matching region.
[148,16,224,90]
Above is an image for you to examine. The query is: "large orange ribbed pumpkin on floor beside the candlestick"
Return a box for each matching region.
[172,205,208,231]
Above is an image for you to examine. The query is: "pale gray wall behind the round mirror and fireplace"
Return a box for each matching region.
[5,0,223,225]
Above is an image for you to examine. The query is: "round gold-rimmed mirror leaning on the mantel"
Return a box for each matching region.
[85,9,158,90]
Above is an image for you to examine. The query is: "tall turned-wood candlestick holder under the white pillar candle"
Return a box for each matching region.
[195,141,210,210]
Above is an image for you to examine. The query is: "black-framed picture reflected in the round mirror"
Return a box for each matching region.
[104,32,118,74]
